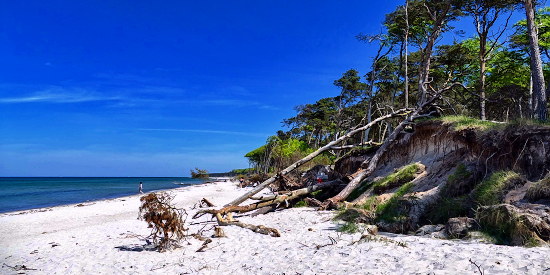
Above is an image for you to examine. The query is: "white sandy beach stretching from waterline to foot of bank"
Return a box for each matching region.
[0,182,550,274]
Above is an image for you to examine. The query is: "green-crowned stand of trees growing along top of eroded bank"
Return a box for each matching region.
[246,0,550,173]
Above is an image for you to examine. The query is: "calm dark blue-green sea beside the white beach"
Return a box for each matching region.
[0,177,203,213]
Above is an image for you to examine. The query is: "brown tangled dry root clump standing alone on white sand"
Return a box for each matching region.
[138,192,188,252]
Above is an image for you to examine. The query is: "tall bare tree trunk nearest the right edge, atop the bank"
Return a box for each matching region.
[525,0,547,121]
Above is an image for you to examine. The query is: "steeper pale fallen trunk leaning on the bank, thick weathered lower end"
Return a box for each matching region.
[322,85,454,209]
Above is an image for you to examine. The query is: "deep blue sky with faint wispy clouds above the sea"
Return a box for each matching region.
[0,0,528,176]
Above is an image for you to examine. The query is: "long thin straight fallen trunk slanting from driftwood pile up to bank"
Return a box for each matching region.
[226,109,409,206]
